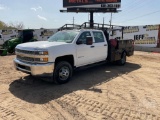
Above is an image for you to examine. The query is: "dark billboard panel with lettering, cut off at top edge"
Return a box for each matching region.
[63,0,121,8]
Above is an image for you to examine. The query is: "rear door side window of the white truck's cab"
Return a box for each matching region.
[93,31,104,43]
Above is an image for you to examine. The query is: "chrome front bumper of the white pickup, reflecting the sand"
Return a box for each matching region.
[14,59,54,77]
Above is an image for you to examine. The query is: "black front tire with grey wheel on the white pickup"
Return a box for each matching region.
[53,61,73,84]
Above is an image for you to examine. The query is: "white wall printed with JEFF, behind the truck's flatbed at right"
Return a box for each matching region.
[113,25,160,47]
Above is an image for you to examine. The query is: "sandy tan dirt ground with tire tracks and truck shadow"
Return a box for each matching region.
[0,52,160,120]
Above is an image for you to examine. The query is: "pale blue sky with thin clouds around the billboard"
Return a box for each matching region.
[0,0,160,29]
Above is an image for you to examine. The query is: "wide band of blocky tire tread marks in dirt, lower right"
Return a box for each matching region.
[56,94,160,120]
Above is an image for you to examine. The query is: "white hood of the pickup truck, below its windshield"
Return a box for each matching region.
[16,41,68,50]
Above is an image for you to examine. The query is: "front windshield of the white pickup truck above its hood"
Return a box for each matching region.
[48,31,79,43]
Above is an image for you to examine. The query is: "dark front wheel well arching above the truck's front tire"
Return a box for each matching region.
[55,55,74,67]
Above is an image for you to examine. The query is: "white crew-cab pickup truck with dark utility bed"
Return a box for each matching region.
[14,29,134,84]
